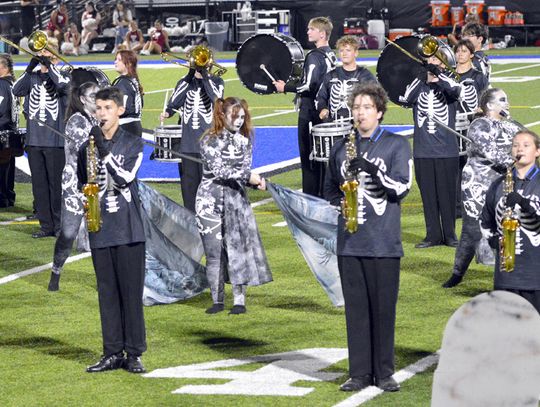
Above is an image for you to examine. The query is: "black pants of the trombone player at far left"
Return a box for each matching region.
[27,146,66,233]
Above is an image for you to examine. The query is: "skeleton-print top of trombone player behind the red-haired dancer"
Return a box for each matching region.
[166,74,224,153]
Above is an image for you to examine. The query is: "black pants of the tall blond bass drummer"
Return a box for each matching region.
[298,116,326,197]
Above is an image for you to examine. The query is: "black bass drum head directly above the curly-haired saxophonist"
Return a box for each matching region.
[377,35,425,107]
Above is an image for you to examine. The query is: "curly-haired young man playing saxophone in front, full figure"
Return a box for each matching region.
[325,83,412,391]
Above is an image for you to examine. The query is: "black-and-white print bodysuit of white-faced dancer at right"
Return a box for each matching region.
[461,117,519,219]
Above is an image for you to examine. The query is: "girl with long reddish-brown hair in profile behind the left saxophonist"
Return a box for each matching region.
[112,50,144,136]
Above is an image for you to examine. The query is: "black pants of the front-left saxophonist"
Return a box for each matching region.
[92,242,146,356]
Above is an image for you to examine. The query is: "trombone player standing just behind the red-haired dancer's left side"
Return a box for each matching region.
[160,63,224,212]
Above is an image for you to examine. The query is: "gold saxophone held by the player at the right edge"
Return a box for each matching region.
[499,161,519,273]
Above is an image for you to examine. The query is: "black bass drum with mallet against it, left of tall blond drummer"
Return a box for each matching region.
[236,34,304,95]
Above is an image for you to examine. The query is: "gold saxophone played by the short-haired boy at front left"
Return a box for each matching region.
[82,136,101,232]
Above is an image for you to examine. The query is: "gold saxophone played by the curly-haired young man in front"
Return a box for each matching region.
[339,126,358,233]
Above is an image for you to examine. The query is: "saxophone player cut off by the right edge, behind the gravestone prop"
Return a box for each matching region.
[480,129,540,312]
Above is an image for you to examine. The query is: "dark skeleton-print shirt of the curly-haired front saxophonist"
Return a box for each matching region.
[325,127,413,257]
